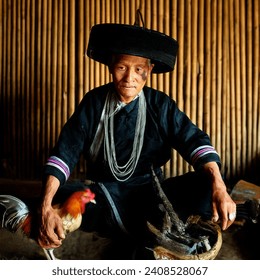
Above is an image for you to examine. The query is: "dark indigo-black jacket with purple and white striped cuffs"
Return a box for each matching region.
[44,83,220,184]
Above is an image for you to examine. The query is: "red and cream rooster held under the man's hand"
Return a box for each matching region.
[0,189,96,260]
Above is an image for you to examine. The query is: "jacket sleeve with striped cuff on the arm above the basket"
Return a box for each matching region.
[149,88,221,170]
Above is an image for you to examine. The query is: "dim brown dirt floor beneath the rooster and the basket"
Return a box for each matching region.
[0,221,260,260]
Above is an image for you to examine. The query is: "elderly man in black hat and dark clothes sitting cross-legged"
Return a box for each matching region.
[39,24,236,258]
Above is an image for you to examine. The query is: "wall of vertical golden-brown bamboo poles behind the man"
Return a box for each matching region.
[0,0,260,185]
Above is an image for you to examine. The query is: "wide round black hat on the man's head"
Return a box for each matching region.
[87,23,178,73]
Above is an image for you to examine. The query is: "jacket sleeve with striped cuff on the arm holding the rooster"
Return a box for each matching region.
[43,84,111,185]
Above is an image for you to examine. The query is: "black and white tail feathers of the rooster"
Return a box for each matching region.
[0,195,30,235]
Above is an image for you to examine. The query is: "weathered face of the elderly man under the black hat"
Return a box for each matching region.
[109,54,153,103]
